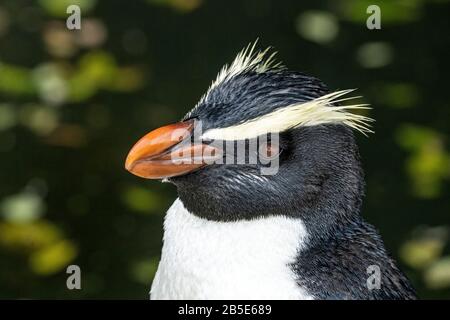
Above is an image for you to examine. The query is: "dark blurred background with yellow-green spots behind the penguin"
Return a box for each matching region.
[0,0,450,299]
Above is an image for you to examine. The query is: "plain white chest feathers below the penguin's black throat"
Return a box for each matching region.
[151,199,312,299]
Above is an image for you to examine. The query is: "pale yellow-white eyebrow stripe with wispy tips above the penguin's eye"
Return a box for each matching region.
[202,89,374,140]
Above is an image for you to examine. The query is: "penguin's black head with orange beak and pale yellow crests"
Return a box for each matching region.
[125,45,370,225]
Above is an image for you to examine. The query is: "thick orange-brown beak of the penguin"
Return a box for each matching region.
[125,120,221,179]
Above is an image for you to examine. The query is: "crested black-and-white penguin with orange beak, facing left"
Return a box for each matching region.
[125,43,416,300]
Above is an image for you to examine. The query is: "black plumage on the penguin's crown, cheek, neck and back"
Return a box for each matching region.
[169,69,415,299]
